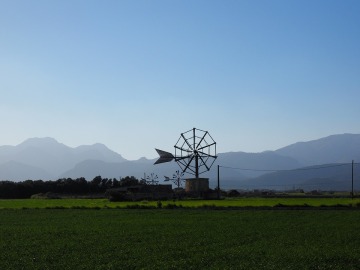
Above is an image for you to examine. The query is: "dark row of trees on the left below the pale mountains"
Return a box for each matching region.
[0,176,145,199]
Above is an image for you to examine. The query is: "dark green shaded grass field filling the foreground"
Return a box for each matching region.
[0,209,360,269]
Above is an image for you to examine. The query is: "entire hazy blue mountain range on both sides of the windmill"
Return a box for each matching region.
[0,134,360,190]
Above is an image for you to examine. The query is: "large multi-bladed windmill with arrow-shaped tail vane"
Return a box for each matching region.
[154,128,217,193]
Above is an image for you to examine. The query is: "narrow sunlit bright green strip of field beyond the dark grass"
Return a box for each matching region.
[0,197,360,209]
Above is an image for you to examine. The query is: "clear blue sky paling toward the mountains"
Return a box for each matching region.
[0,0,360,159]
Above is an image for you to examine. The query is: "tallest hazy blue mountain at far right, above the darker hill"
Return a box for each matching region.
[275,134,360,166]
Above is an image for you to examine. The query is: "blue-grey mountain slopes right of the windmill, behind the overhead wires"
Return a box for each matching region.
[208,134,360,190]
